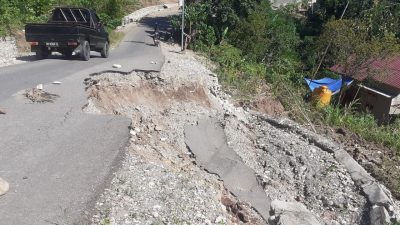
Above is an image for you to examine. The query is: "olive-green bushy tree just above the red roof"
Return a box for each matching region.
[317,20,400,78]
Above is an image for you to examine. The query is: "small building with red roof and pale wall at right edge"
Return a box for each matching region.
[331,56,400,123]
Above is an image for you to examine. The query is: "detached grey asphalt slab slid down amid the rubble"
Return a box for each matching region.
[185,119,271,221]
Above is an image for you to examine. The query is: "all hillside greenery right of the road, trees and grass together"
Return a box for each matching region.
[171,0,400,198]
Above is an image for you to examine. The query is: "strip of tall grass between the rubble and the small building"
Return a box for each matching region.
[203,40,400,152]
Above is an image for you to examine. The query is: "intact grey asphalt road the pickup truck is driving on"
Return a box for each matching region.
[0,13,164,225]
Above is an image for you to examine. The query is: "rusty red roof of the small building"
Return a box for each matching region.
[331,56,400,90]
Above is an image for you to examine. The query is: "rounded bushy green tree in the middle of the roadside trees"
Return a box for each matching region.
[230,1,300,74]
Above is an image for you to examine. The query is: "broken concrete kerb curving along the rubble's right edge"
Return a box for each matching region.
[251,111,400,225]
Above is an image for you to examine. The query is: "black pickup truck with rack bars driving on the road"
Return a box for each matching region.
[25,7,110,61]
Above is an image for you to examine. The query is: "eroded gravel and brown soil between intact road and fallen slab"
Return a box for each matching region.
[85,69,264,224]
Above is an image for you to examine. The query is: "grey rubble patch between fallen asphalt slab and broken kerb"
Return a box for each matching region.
[245,117,367,225]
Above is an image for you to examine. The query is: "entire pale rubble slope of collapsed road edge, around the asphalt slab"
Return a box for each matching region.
[85,40,398,225]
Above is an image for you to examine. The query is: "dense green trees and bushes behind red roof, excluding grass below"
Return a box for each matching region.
[173,0,400,97]
